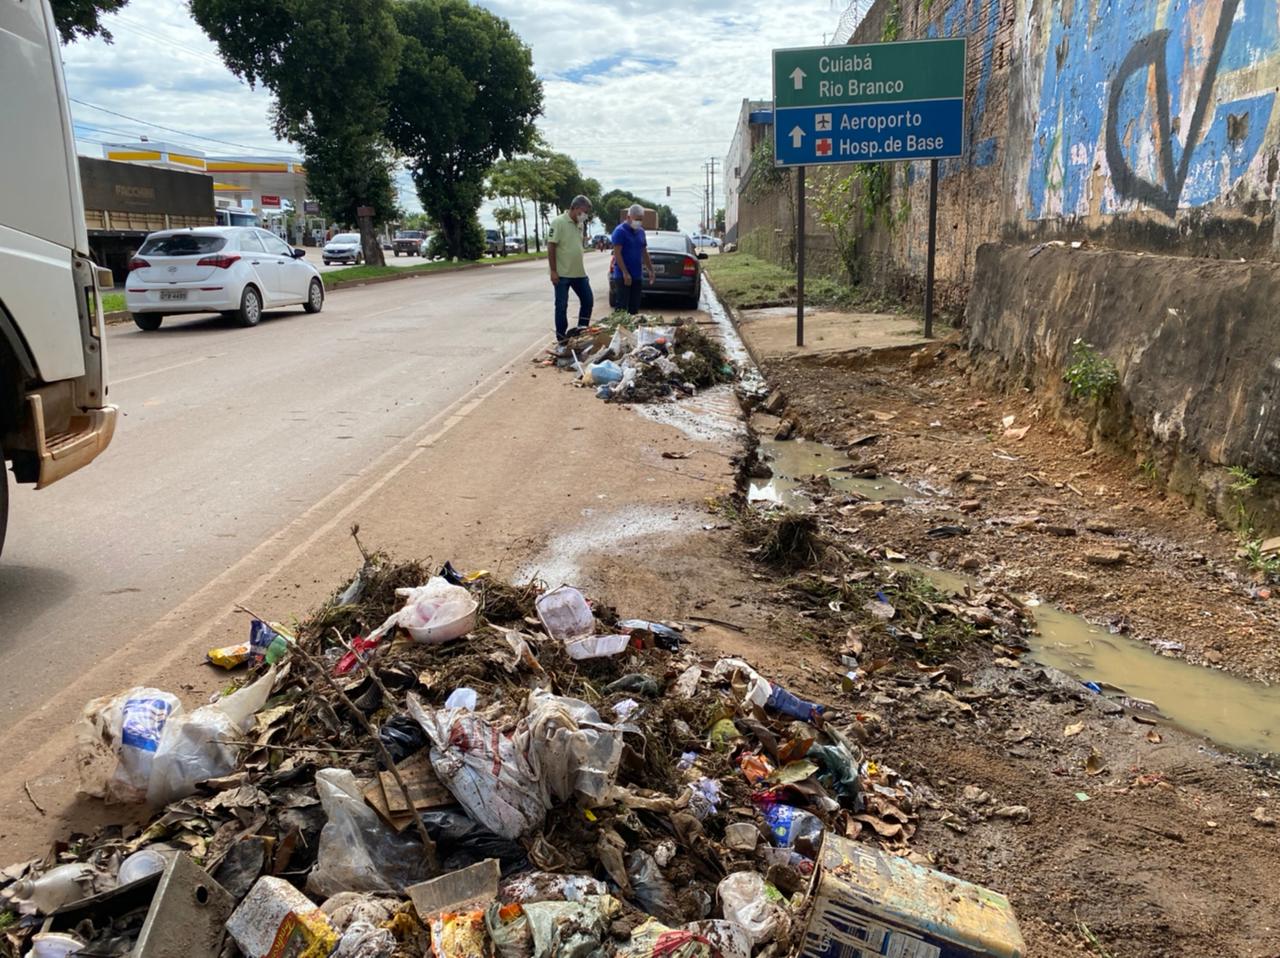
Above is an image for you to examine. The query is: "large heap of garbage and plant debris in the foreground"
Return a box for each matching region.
[0,539,1021,958]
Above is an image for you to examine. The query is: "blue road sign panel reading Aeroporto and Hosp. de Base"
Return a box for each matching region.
[773,99,964,166]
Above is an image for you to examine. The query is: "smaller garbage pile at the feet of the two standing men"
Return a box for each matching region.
[545,313,737,402]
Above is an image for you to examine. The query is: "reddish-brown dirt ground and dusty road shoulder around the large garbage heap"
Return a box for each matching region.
[0,297,1280,958]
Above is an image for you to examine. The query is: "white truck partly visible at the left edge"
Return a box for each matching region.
[0,0,116,558]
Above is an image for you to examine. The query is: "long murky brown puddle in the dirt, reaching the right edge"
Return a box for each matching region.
[893,564,1280,752]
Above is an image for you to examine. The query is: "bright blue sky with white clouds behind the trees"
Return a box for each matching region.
[64,0,850,229]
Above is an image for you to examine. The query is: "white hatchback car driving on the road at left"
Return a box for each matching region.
[124,227,324,330]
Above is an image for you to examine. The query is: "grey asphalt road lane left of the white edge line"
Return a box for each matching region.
[0,256,565,729]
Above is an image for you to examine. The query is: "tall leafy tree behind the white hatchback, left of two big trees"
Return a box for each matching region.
[191,0,402,264]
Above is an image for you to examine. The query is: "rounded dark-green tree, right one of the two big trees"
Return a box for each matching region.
[381,0,543,257]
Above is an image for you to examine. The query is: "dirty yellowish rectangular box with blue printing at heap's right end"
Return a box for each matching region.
[800,832,1025,958]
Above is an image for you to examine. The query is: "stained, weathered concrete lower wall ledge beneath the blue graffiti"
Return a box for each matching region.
[968,243,1280,519]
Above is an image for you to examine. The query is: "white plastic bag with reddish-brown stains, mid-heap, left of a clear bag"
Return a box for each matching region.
[408,694,547,839]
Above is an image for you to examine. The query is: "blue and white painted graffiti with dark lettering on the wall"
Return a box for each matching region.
[1027,0,1280,219]
